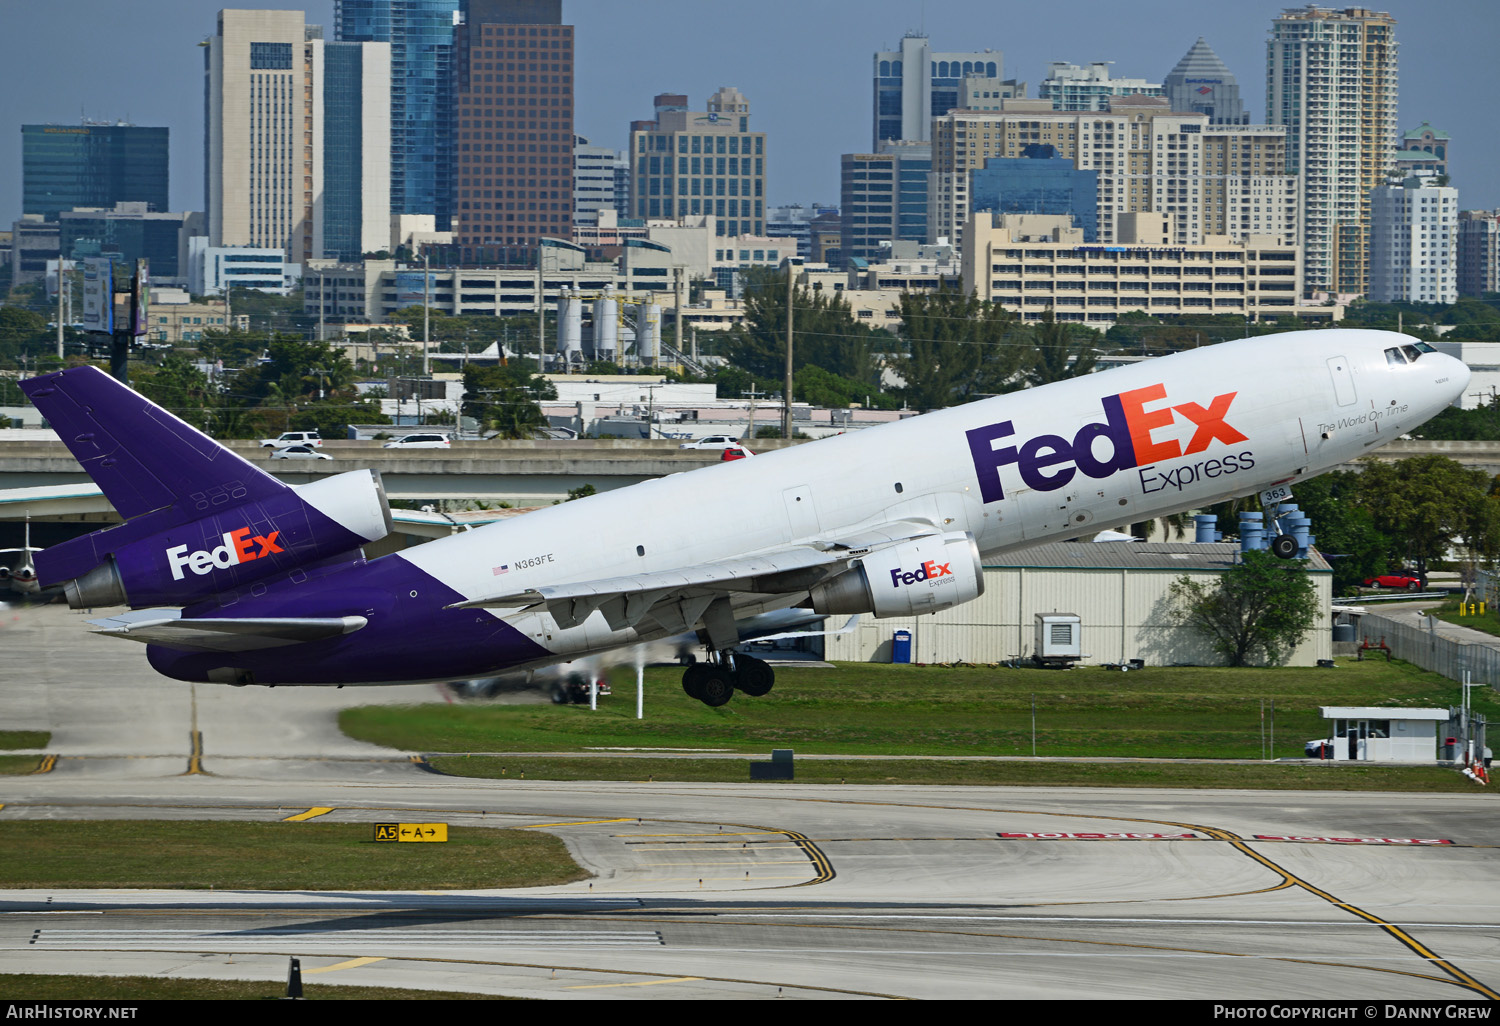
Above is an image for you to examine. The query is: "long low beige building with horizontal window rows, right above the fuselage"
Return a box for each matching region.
[963,212,1334,330]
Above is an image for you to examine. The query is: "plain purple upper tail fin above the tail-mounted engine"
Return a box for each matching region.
[21,366,288,527]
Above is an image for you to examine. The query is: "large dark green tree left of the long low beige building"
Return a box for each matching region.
[891,290,1026,410]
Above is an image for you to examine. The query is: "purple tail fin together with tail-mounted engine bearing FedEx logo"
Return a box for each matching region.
[21,366,390,608]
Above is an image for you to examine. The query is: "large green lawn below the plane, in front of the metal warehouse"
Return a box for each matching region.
[339,660,1500,759]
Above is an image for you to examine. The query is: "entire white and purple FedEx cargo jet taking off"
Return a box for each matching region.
[21,330,1469,705]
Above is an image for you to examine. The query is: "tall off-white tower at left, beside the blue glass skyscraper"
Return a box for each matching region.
[204,11,323,264]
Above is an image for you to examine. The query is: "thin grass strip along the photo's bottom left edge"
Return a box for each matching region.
[0,974,521,1002]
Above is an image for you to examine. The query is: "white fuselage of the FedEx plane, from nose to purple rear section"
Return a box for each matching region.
[396,330,1469,663]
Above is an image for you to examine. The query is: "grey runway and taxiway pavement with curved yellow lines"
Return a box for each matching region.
[0,597,1500,1002]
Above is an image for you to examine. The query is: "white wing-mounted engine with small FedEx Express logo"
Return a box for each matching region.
[812,531,984,617]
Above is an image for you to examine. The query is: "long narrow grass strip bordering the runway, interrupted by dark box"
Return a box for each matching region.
[429,756,1485,794]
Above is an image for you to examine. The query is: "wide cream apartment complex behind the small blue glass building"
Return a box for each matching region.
[927,98,1301,246]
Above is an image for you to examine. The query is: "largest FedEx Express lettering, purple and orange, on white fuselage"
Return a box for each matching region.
[966,384,1256,503]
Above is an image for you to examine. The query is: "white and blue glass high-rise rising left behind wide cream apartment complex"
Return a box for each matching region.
[872,33,1026,150]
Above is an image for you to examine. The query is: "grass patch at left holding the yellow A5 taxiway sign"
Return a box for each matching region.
[0,819,588,891]
